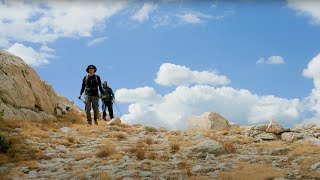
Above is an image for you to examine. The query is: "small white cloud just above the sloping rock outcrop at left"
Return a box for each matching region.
[7,43,54,66]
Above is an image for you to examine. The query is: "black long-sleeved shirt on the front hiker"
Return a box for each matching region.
[80,75,103,96]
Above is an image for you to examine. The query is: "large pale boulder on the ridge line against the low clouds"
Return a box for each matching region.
[189,112,231,131]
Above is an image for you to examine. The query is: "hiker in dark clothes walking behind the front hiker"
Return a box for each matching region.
[102,81,114,121]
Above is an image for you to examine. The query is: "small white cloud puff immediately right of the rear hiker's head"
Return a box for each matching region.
[115,86,162,104]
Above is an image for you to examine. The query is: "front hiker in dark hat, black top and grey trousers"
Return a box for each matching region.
[79,65,103,125]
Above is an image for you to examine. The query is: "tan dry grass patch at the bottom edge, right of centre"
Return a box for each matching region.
[220,163,287,180]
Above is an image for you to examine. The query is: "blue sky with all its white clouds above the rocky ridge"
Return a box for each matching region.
[0,0,320,129]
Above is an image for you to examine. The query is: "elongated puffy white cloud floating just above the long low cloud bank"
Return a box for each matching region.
[155,63,230,86]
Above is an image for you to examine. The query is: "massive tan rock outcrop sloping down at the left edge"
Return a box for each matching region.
[0,50,80,120]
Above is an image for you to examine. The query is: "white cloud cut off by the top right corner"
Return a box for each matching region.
[288,0,320,25]
